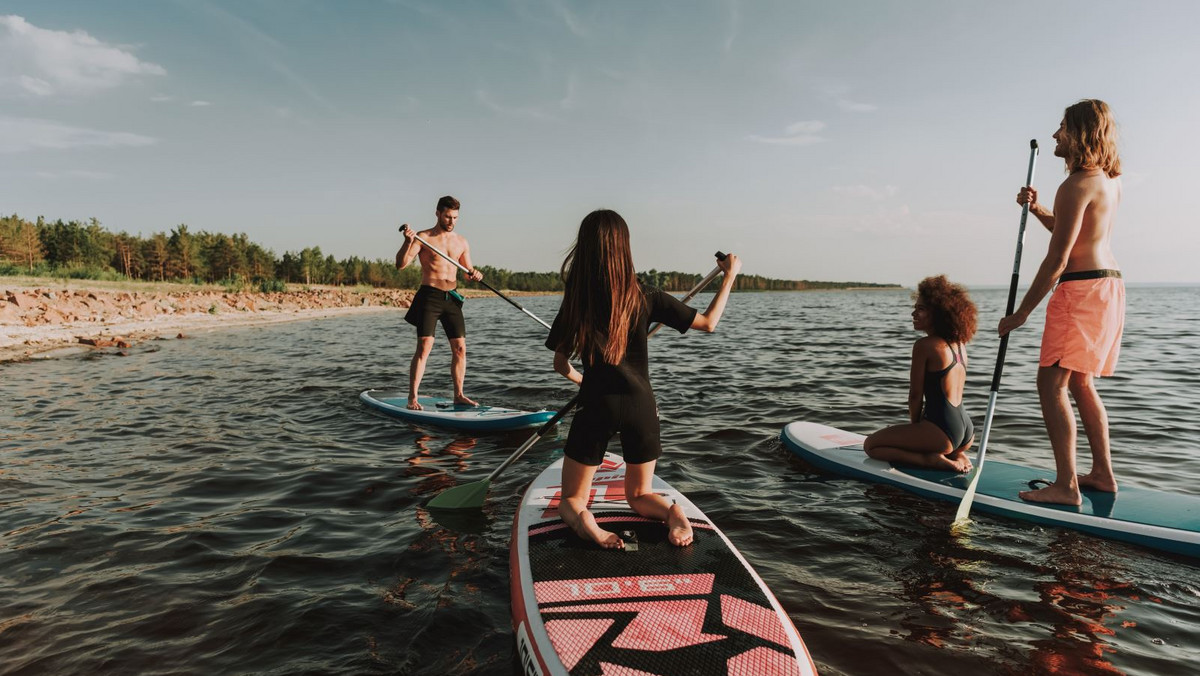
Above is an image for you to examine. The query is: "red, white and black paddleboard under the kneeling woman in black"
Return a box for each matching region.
[509,454,816,676]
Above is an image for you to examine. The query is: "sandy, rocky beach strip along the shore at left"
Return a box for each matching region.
[0,277,424,361]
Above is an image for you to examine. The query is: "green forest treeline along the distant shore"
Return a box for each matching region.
[0,214,894,292]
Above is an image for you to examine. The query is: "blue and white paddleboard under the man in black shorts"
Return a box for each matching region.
[359,390,554,432]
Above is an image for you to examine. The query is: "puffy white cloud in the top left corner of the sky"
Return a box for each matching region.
[0,14,167,97]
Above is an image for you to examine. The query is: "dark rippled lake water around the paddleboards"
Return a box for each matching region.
[0,287,1200,675]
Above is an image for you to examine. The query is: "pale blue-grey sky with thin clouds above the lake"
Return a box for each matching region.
[0,0,1200,286]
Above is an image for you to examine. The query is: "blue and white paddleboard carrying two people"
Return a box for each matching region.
[781,423,1200,557]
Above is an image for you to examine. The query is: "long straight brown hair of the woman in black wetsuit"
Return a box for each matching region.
[558,209,644,365]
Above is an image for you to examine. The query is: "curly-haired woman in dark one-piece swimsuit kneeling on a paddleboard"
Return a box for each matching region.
[863,275,978,472]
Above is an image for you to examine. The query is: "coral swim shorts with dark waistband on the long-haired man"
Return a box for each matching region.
[1038,270,1124,376]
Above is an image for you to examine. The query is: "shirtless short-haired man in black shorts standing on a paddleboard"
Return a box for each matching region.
[396,195,484,411]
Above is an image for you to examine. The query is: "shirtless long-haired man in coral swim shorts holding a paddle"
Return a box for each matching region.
[1000,100,1124,504]
